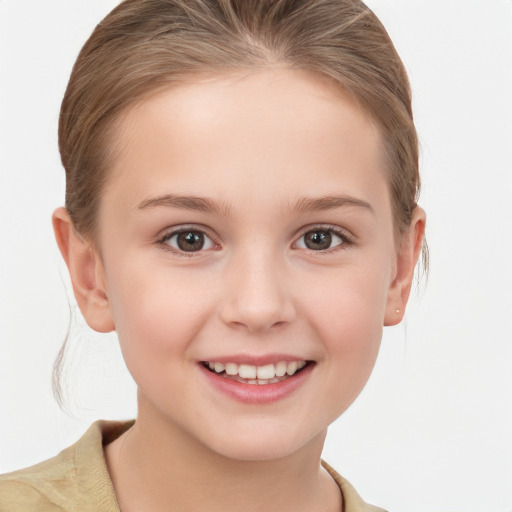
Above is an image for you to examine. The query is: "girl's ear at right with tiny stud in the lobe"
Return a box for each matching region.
[384,206,426,326]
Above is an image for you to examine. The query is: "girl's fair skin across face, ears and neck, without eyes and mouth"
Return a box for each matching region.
[54,68,425,512]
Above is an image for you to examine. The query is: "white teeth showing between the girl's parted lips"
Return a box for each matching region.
[201,360,314,385]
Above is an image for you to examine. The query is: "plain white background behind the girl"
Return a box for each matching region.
[0,0,512,512]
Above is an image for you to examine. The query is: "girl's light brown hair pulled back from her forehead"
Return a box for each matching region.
[54,0,427,404]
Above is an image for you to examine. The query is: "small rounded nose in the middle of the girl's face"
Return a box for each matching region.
[221,251,295,332]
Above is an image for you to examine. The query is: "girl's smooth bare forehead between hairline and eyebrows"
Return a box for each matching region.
[107,69,386,214]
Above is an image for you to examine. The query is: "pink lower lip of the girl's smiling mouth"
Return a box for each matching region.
[199,364,315,404]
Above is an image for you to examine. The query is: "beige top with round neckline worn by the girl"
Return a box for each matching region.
[0,421,383,512]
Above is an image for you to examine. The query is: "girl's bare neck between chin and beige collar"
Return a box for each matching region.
[105,392,341,512]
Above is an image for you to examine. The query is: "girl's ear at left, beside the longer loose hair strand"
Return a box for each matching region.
[52,208,115,332]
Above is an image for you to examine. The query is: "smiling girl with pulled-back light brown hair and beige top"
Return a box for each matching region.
[0,0,425,512]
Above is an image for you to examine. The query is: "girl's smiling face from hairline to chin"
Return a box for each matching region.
[86,69,414,460]
